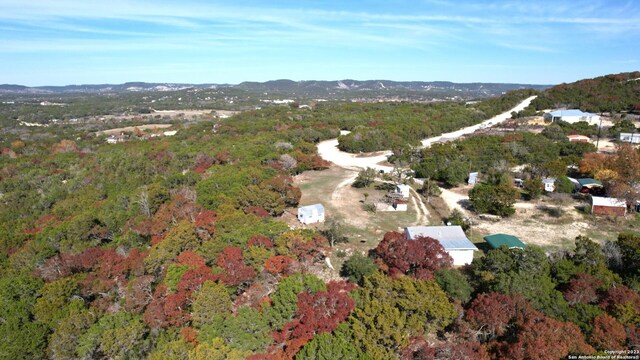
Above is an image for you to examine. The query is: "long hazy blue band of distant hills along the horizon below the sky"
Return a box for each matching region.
[0,80,550,99]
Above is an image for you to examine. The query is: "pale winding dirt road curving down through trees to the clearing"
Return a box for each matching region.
[318,96,536,172]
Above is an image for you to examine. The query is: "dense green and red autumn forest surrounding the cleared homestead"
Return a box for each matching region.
[0,78,640,360]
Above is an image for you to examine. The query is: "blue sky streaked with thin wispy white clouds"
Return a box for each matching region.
[0,0,640,86]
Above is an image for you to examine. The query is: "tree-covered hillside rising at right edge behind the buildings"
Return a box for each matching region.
[531,71,640,113]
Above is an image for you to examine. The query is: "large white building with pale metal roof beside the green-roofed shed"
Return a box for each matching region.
[404,225,478,266]
